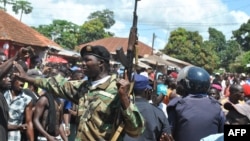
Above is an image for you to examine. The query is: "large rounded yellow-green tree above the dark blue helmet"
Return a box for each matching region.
[162,28,217,72]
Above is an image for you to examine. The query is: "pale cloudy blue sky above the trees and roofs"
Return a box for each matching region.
[4,0,250,49]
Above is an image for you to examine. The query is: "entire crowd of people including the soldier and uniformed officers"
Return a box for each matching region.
[0,45,250,141]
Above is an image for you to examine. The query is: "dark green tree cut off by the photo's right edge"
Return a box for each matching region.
[232,19,250,51]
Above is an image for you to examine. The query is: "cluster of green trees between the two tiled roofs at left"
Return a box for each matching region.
[33,9,115,50]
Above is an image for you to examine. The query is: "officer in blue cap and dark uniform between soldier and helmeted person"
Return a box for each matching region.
[124,74,172,141]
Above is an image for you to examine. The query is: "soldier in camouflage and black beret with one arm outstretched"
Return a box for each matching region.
[16,46,144,141]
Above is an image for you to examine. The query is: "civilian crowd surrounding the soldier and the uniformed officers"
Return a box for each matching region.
[0,46,250,141]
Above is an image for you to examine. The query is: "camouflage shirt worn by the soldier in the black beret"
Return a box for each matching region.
[35,75,144,141]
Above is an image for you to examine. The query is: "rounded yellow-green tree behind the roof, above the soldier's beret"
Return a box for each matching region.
[78,18,110,44]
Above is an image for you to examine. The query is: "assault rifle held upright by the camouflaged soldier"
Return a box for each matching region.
[111,0,140,141]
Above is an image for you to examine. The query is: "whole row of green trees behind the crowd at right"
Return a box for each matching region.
[162,20,250,72]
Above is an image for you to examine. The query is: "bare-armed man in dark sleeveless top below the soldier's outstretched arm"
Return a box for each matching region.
[33,67,68,141]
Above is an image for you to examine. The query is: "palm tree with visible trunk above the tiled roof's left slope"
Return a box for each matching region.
[12,0,33,21]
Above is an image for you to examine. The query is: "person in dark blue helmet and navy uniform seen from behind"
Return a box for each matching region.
[167,66,225,141]
